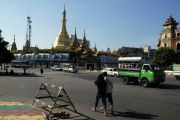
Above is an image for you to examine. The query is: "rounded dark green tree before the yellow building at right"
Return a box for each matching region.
[154,47,178,68]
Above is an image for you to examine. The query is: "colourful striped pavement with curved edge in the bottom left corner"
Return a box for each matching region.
[0,101,44,120]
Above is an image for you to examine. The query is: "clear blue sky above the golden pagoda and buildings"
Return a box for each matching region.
[0,0,180,50]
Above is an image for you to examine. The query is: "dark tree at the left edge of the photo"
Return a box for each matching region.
[0,30,14,65]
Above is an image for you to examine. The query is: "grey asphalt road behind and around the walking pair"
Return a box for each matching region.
[0,69,180,120]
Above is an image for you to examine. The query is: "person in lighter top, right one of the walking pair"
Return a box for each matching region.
[104,76,114,115]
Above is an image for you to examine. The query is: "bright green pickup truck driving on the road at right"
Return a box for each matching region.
[118,64,165,87]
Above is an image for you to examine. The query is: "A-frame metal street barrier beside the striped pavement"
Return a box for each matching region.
[32,83,77,120]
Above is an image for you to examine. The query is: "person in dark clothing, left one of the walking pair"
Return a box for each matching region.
[92,72,107,115]
